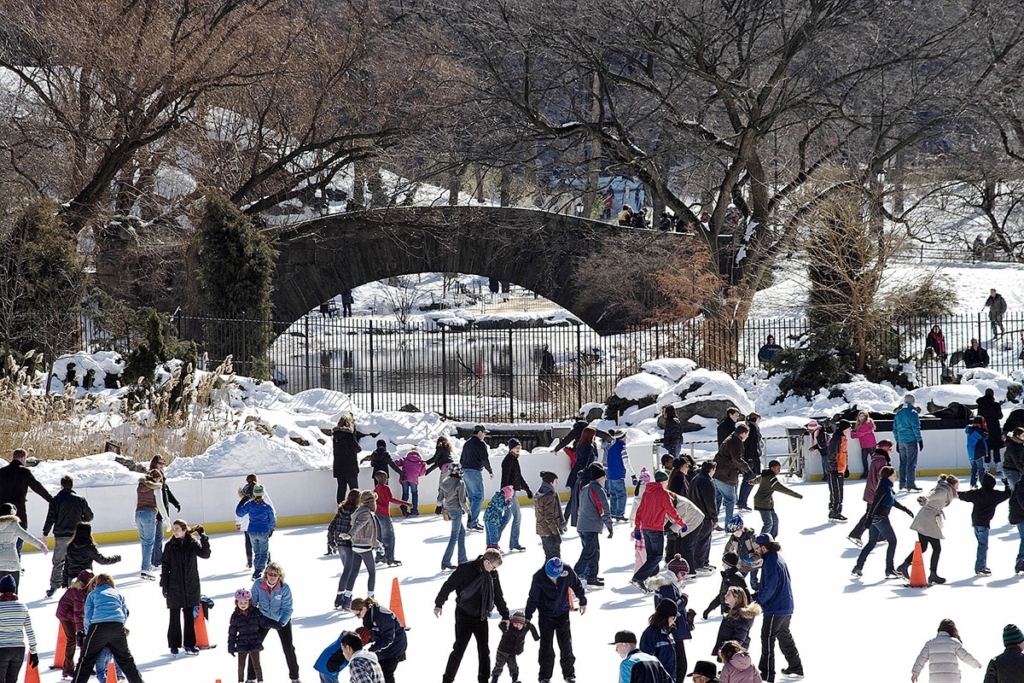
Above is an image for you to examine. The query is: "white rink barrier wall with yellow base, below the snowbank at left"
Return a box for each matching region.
[27,452,569,550]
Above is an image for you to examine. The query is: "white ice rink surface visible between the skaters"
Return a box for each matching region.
[22,480,1024,683]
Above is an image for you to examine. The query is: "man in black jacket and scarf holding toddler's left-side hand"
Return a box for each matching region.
[434,548,509,683]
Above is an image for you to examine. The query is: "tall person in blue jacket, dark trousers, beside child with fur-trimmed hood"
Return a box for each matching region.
[757,533,804,683]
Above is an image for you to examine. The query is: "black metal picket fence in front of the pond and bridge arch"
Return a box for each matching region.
[75,311,1024,423]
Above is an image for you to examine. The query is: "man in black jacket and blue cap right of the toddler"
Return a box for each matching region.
[528,557,587,683]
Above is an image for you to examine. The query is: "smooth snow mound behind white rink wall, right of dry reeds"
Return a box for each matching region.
[166,430,331,479]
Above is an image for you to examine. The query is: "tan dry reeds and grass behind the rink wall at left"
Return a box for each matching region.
[0,354,234,462]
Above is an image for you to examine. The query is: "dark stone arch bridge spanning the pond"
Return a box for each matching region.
[273,206,683,332]
